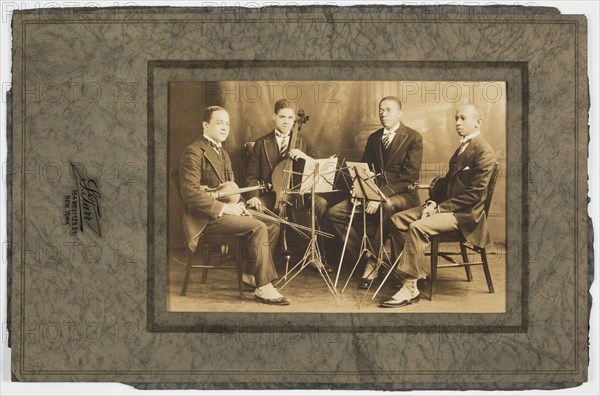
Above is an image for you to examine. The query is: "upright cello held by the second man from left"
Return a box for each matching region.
[271,109,310,213]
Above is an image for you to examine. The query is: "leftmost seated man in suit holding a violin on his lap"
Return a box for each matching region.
[179,106,290,305]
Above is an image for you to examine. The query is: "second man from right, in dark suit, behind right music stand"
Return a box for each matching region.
[329,96,423,289]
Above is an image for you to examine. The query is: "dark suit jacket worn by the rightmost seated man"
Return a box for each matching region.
[439,135,496,246]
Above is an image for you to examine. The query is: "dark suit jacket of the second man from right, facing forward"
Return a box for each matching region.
[362,124,423,197]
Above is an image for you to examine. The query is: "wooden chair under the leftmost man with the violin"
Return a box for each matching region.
[169,168,248,300]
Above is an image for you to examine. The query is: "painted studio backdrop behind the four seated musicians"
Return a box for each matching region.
[167,81,506,248]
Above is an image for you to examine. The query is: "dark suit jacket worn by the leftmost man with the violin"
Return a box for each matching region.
[179,137,234,251]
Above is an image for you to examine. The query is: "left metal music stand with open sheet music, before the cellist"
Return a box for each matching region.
[275,158,340,305]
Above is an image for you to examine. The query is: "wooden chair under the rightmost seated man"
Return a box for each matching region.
[425,162,499,300]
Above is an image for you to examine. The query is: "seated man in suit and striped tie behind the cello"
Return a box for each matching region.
[246,99,332,273]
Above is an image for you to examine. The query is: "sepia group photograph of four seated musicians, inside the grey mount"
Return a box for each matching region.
[165,81,507,314]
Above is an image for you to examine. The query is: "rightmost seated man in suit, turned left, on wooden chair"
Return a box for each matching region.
[380,105,496,307]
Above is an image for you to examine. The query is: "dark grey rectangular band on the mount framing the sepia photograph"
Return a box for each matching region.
[147,60,530,333]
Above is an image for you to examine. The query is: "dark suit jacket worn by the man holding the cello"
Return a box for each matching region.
[246,130,316,198]
